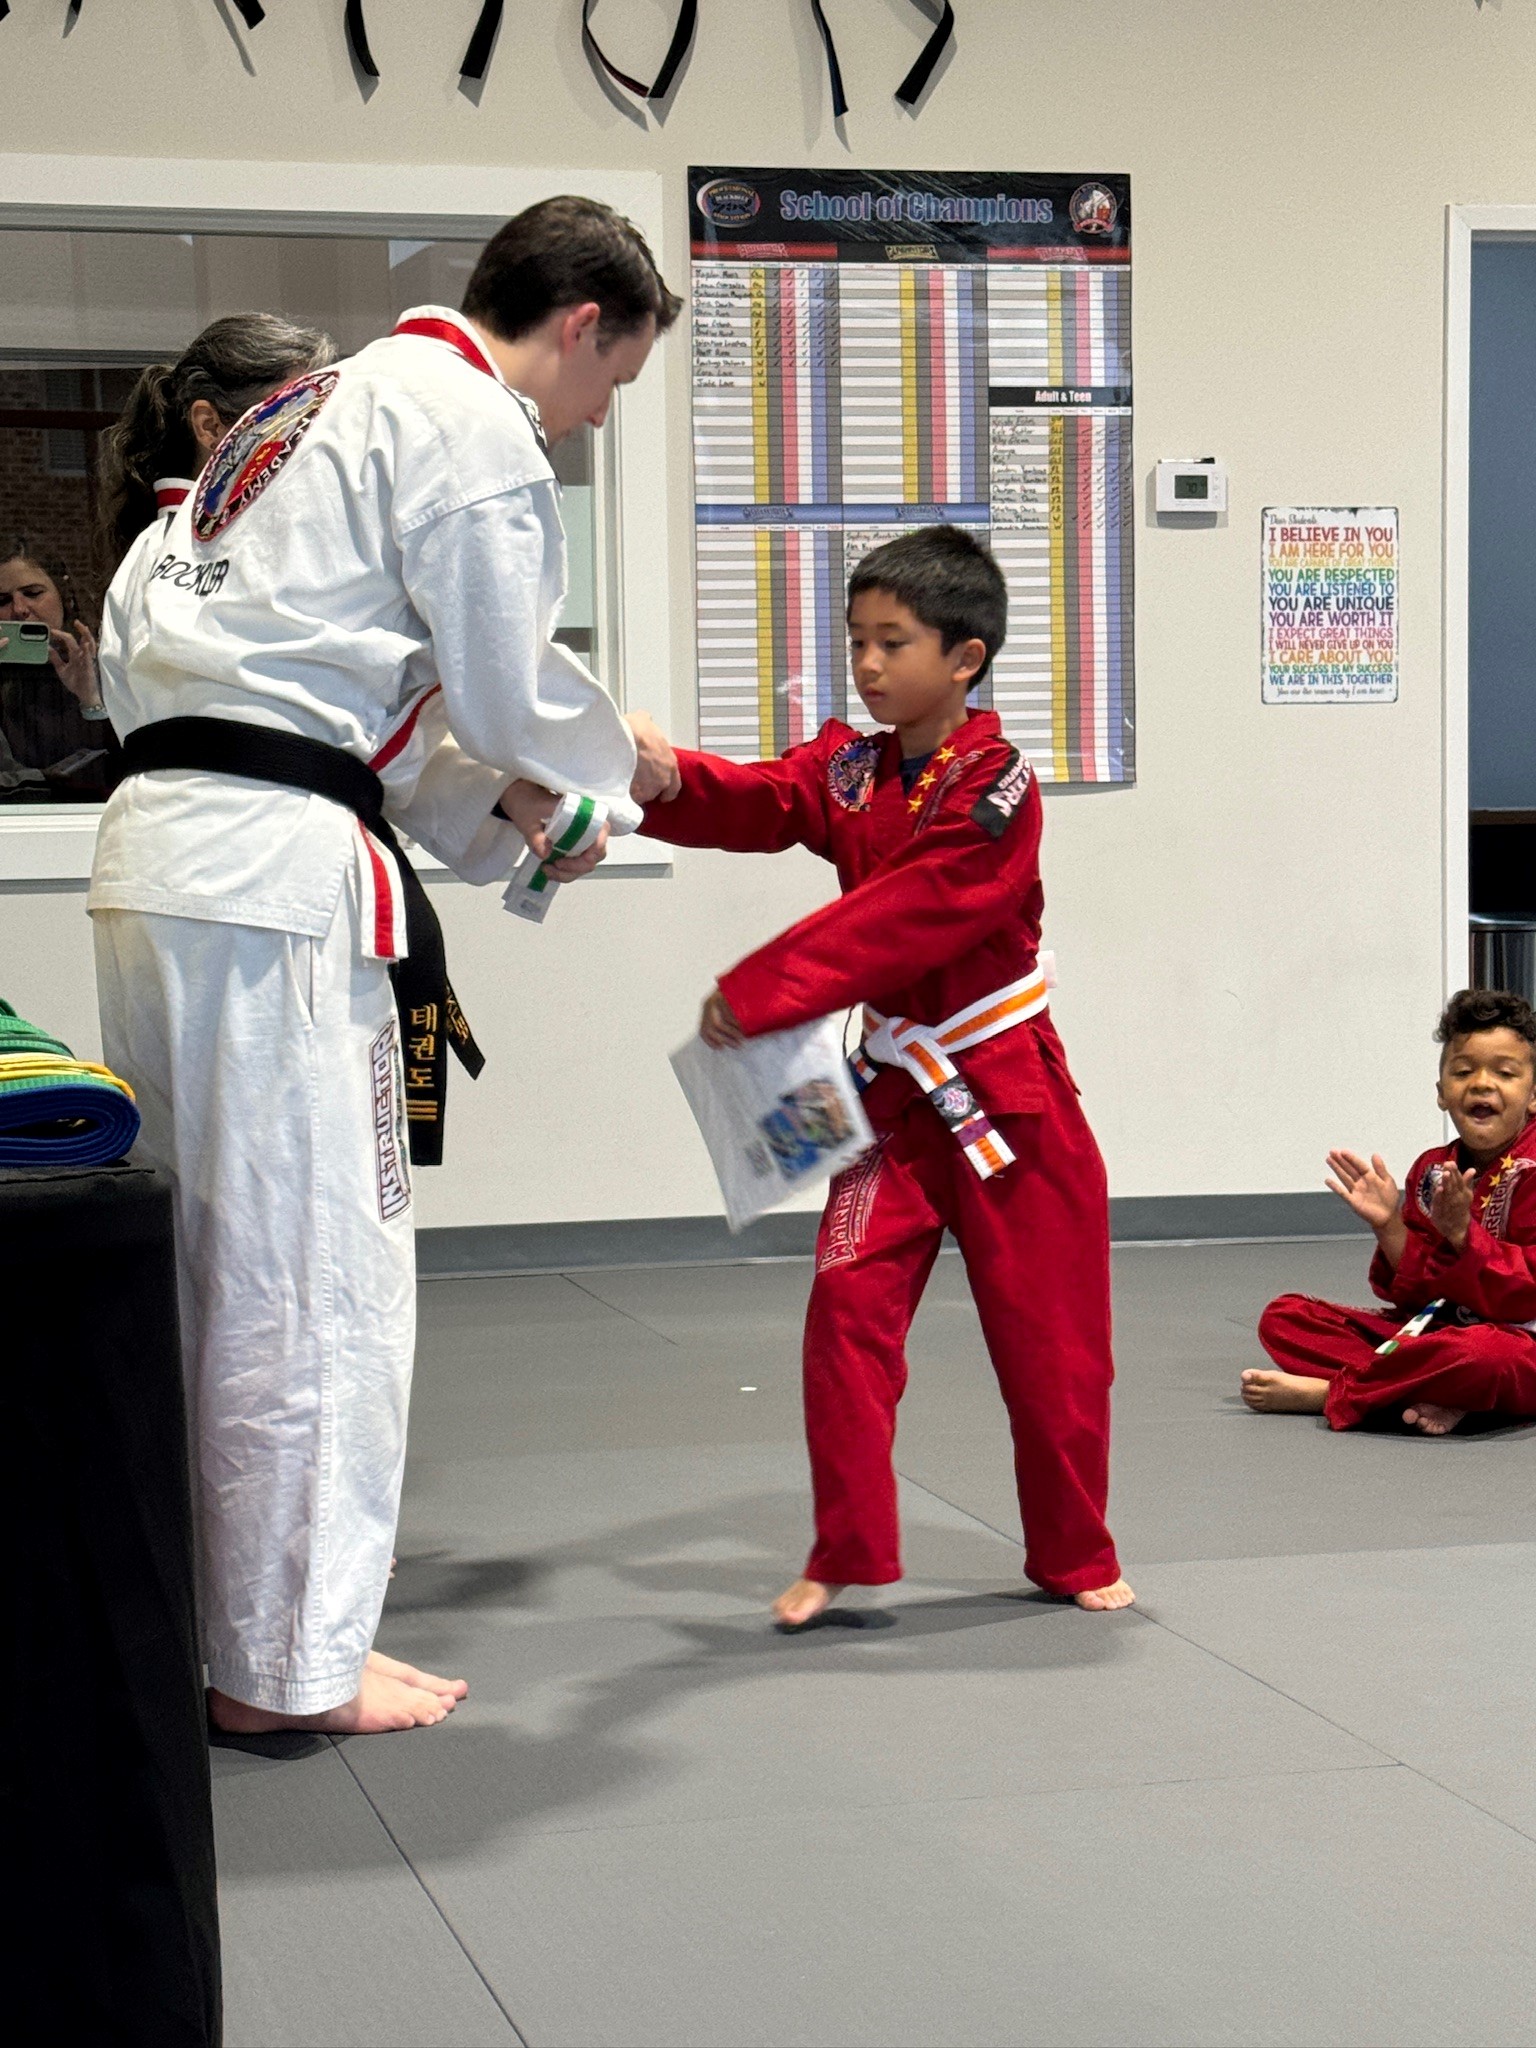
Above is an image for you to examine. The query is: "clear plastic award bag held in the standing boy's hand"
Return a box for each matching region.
[672,1018,874,1231]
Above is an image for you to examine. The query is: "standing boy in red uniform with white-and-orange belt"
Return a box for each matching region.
[641,526,1135,1626]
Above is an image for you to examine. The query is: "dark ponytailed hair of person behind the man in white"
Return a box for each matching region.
[98,313,336,561]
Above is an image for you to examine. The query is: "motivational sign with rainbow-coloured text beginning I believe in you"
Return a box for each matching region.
[1264,506,1397,705]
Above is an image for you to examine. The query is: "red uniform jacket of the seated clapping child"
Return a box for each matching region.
[1370,1120,1536,1323]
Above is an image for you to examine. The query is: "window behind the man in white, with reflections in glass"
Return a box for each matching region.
[0,227,618,809]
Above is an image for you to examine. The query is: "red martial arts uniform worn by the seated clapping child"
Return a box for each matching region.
[1260,1122,1536,1430]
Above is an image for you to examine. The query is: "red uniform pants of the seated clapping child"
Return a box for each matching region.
[1260,1294,1536,1430]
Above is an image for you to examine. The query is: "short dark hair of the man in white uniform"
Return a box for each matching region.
[463,197,682,342]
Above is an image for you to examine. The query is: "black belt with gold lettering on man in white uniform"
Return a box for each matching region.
[123,719,485,1165]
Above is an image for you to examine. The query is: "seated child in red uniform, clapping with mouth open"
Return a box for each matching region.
[1243,989,1536,1436]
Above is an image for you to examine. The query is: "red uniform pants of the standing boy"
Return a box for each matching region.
[805,1065,1120,1593]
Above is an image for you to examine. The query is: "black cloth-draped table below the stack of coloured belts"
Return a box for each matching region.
[0,1163,219,2048]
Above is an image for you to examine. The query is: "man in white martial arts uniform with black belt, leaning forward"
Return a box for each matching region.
[88,199,678,1733]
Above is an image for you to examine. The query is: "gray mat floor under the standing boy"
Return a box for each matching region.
[213,1241,1536,2048]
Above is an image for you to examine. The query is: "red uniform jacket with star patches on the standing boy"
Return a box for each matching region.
[641,711,1065,1116]
